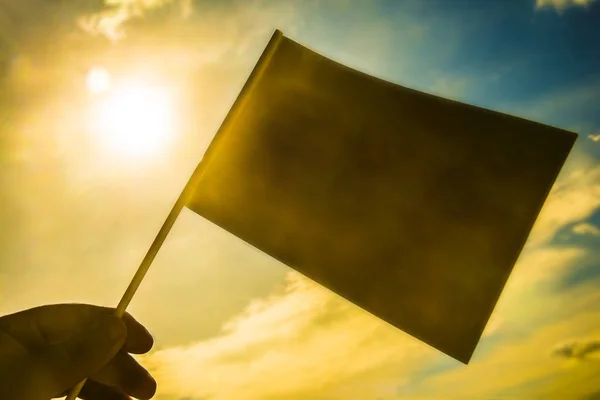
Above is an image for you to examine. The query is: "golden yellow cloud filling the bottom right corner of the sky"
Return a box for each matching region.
[414,300,600,400]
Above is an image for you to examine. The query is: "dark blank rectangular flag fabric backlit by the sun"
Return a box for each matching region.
[186,31,577,363]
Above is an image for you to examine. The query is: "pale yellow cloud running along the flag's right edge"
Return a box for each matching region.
[482,159,600,333]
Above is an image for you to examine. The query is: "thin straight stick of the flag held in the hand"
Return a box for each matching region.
[65,29,283,400]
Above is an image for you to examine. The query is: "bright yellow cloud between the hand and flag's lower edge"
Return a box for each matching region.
[141,273,435,400]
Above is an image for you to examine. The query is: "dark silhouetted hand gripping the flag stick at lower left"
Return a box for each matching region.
[0,304,156,400]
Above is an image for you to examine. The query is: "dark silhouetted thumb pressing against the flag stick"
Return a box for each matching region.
[38,315,127,393]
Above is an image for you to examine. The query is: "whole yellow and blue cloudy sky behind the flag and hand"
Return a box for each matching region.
[0,0,600,400]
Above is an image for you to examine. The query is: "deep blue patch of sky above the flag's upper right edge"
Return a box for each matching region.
[381,0,600,133]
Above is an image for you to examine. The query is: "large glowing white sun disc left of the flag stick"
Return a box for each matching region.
[88,76,177,160]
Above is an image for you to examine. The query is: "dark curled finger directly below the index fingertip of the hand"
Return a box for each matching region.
[91,352,156,400]
